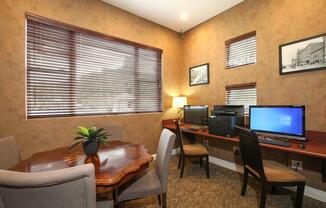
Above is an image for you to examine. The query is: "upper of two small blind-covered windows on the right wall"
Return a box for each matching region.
[225,31,256,68]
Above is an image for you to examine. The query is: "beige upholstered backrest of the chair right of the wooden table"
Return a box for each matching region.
[155,129,176,193]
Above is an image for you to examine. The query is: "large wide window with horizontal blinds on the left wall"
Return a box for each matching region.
[26,15,162,118]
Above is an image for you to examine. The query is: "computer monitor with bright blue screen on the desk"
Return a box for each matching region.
[249,106,306,140]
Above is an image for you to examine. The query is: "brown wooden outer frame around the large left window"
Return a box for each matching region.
[25,12,164,119]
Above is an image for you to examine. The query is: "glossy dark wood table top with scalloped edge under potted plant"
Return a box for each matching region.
[11,141,153,193]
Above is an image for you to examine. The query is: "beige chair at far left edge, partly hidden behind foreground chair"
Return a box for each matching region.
[0,136,20,169]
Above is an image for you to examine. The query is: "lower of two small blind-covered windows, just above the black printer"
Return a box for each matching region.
[225,83,257,115]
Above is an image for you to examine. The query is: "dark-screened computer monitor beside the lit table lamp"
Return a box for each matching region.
[183,105,208,125]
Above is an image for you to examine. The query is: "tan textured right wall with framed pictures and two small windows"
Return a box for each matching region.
[182,0,326,131]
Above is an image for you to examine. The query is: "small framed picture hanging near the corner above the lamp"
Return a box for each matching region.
[189,63,209,86]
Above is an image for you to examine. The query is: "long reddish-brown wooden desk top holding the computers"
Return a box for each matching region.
[162,119,326,159]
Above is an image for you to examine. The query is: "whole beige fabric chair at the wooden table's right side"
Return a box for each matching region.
[117,129,176,207]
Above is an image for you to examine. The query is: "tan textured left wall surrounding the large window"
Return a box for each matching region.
[0,0,181,158]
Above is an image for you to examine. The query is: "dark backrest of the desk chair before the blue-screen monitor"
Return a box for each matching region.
[237,127,266,180]
